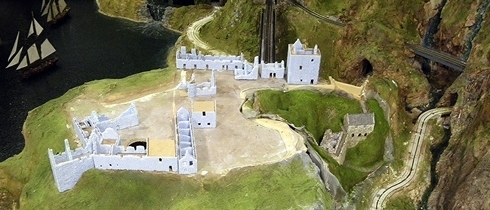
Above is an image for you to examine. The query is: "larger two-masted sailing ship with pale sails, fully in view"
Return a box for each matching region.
[7,18,58,78]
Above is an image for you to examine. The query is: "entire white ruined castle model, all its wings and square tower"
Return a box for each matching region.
[48,39,321,192]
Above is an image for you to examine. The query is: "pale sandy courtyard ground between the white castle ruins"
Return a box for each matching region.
[68,71,306,174]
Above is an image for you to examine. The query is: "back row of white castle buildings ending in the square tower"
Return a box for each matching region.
[175,39,321,85]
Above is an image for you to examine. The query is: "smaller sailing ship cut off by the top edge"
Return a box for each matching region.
[41,0,70,25]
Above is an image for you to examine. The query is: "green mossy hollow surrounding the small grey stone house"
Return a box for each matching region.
[254,90,389,191]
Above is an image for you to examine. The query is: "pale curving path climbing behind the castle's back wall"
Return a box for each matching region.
[186,7,226,55]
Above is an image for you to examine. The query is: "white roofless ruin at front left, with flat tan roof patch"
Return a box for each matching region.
[48,104,201,192]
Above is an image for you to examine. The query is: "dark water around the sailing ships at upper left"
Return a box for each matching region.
[0,0,179,161]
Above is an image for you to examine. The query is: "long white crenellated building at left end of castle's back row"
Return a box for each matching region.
[175,46,245,70]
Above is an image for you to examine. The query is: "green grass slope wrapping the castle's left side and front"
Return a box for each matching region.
[0,68,332,209]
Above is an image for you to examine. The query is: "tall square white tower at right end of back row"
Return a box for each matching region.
[286,39,321,85]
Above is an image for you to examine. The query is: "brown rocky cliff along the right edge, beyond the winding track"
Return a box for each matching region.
[428,0,490,209]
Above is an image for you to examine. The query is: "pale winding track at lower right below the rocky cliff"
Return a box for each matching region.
[371,108,451,209]
